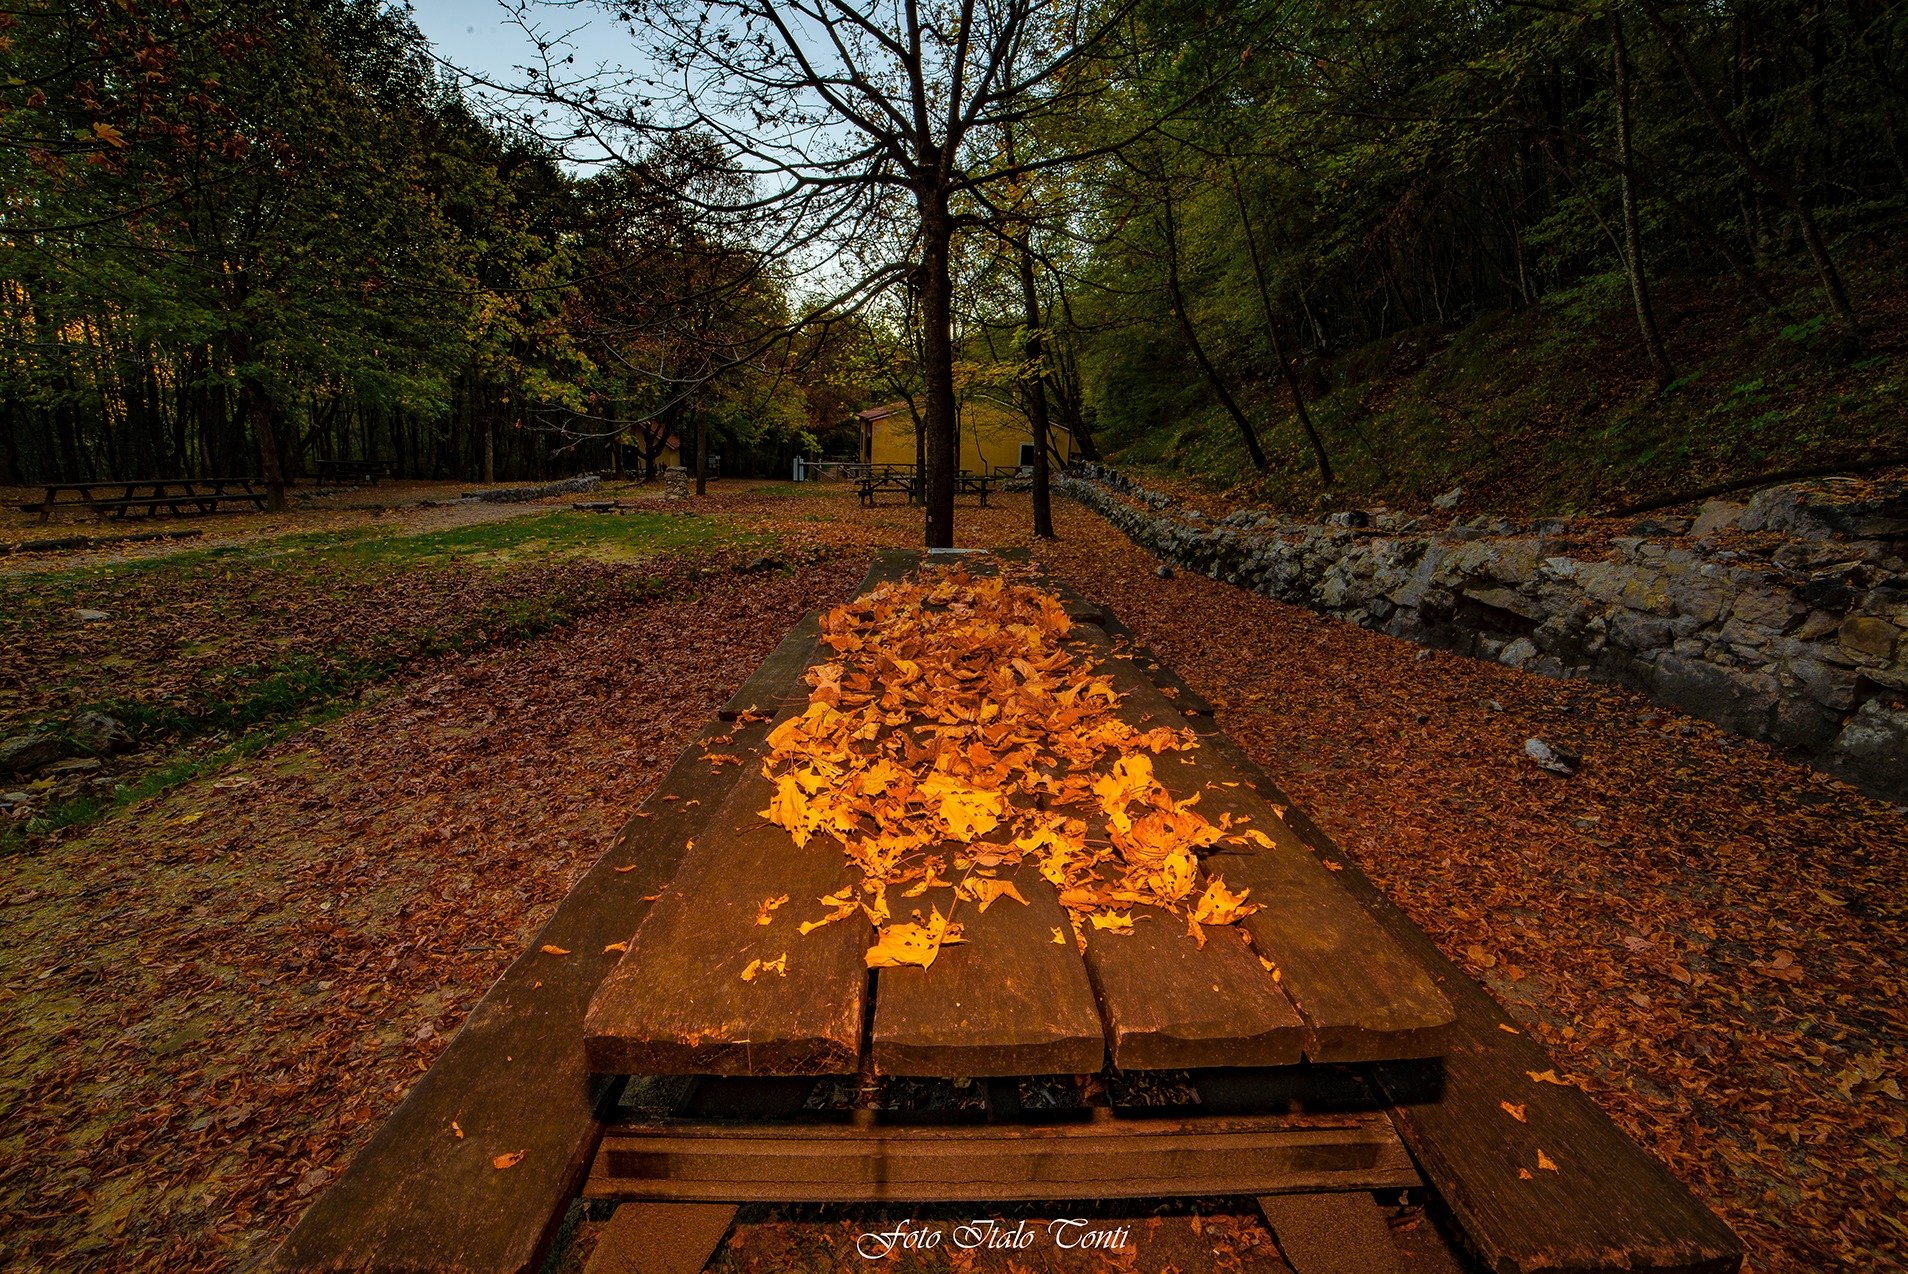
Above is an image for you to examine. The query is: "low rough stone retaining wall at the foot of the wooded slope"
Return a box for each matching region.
[1055,465,1908,801]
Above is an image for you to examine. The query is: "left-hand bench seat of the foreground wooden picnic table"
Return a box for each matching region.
[271,723,767,1272]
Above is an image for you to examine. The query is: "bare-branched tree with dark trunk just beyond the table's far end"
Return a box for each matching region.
[519,0,1225,547]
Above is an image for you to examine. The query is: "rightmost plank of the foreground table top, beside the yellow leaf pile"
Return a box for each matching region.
[1076,625,1454,1062]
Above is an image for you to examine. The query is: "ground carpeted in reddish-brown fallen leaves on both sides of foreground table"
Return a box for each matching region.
[0,484,1908,1272]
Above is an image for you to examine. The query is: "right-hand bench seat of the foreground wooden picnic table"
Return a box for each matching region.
[1175,724,1742,1274]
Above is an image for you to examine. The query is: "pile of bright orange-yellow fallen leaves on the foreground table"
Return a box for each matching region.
[761,565,1259,967]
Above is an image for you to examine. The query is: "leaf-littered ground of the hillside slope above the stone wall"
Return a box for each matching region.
[1101,252,1908,517]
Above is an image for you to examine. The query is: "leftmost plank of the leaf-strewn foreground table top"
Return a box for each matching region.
[584,767,872,1076]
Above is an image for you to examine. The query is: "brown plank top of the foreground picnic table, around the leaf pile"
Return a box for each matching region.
[586,553,1454,1076]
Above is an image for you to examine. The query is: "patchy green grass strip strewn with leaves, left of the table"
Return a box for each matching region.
[0,509,761,853]
